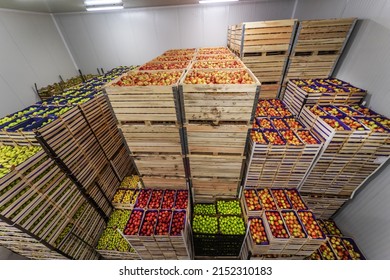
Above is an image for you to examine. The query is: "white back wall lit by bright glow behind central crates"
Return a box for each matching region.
[55,0,294,72]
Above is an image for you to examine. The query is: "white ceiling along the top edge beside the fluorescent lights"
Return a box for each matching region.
[0,0,262,13]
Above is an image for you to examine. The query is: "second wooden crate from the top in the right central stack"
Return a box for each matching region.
[184,121,250,156]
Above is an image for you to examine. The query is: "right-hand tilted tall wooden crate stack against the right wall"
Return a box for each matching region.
[284,18,356,95]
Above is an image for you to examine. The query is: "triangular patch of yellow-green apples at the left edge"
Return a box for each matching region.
[0,146,41,178]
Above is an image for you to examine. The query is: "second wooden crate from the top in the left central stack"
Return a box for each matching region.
[119,120,182,156]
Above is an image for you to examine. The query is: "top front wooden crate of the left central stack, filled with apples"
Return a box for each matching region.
[105,70,184,124]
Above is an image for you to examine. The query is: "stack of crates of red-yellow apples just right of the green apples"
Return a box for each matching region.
[242,187,326,259]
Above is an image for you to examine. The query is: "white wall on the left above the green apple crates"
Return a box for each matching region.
[0,10,77,117]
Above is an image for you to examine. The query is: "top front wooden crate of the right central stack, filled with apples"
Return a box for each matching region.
[179,69,260,124]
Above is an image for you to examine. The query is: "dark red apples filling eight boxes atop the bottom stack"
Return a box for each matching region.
[123,189,188,236]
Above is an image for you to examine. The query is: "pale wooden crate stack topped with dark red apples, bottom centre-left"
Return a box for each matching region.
[123,189,192,260]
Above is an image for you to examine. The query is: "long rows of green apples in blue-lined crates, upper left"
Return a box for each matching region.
[0,67,130,135]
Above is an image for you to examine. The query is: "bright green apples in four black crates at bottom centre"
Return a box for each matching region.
[192,200,245,235]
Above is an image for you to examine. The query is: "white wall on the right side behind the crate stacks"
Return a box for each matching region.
[295,0,390,259]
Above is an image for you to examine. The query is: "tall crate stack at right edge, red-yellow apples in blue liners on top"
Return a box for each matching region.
[300,105,390,218]
